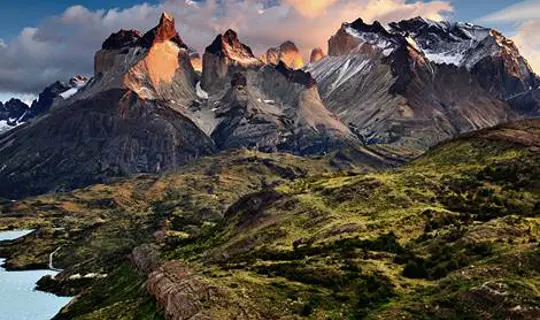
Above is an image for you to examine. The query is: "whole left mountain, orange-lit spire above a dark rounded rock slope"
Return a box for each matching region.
[0,14,214,198]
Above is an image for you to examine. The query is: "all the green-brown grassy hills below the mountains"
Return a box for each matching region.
[0,120,540,319]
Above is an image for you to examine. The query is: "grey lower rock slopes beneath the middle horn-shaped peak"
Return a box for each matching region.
[212,61,358,154]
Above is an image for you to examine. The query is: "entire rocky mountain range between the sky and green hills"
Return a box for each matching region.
[0,14,540,198]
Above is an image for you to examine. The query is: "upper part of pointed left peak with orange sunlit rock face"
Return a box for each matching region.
[92,14,196,105]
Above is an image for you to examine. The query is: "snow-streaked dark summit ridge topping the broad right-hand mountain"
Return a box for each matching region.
[329,17,519,69]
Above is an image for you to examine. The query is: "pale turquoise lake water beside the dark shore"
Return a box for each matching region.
[0,231,71,320]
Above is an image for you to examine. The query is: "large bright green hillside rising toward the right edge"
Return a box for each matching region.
[141,121,540,319]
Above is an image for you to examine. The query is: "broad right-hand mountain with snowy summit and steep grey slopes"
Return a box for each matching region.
[309,18,536,148]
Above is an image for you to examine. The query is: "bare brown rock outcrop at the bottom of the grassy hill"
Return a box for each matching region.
[146,262,263,320]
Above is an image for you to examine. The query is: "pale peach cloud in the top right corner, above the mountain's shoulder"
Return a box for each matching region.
[480,0,540,72]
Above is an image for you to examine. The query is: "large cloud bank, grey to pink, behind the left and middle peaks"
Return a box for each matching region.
[0,0,452,93]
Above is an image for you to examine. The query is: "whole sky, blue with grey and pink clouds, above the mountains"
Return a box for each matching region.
[0,0,540,101]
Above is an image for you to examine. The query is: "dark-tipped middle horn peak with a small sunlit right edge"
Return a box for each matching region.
[201,30,263,93]
